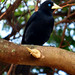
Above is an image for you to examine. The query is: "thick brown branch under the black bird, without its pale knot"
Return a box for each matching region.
[0,39,75,75]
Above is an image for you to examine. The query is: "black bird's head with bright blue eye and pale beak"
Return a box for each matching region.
[39,0,61,12]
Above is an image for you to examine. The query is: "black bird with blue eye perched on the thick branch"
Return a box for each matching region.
[16,0,61,75]
